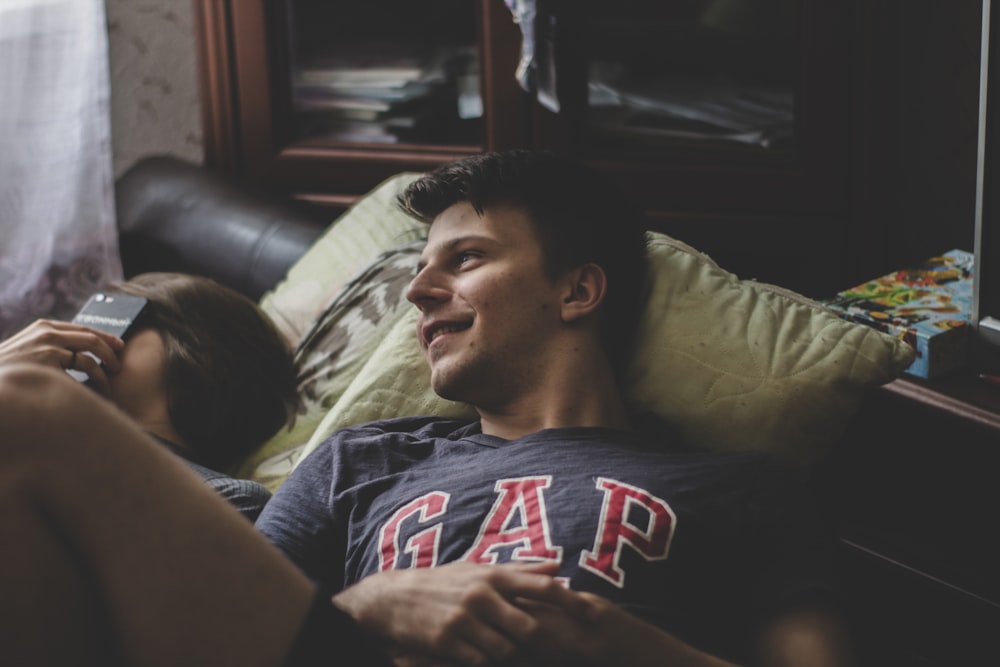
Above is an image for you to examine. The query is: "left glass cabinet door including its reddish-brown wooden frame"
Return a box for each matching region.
[196,0,527,204]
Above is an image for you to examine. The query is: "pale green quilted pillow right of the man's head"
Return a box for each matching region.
[626,233,914,463]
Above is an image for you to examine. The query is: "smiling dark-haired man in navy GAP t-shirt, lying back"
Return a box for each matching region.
[257,151,849,665]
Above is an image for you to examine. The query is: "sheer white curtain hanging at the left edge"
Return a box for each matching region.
[0,0,121,337]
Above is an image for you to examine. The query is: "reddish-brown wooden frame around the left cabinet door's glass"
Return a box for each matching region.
[195,0,527,207]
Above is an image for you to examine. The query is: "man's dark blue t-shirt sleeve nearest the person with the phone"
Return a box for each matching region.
[256,436,344,591]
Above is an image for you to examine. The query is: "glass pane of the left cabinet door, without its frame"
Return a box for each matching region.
[281,0,483,145]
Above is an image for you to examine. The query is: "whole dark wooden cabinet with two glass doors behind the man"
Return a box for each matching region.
[195,0,977,298]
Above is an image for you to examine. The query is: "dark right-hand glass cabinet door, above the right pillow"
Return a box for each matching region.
[533,0,852,218]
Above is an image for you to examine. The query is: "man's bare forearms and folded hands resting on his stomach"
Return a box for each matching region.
[333,563,854,667]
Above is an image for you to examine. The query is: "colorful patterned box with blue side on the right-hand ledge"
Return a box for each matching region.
[824,250,974,378]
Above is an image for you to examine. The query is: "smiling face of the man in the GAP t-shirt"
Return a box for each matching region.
[407,202,564,407]
